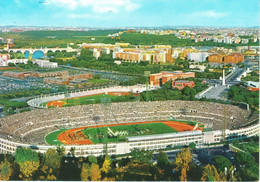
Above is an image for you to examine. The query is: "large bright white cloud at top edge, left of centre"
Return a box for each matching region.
[46,0,140,13]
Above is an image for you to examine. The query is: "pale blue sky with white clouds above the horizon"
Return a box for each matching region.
[0,0,259,27]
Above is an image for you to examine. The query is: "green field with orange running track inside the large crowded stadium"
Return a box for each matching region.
[45,120,209,145]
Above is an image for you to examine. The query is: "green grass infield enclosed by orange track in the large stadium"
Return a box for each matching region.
[83,123,178,143]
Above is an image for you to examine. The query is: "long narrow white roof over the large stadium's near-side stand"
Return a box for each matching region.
[126,130,202,142]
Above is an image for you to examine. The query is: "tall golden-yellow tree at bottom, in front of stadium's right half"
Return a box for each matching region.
[175,148,192,181]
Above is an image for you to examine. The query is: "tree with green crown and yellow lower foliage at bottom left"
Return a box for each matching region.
[15,148,40,179]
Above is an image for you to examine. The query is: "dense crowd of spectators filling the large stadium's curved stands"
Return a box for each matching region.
[0,101,258,144]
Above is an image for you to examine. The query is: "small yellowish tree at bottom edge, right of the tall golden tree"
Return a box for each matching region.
[201,164,223,181]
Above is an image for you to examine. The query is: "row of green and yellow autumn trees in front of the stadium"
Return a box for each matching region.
[0,138,259,181]
